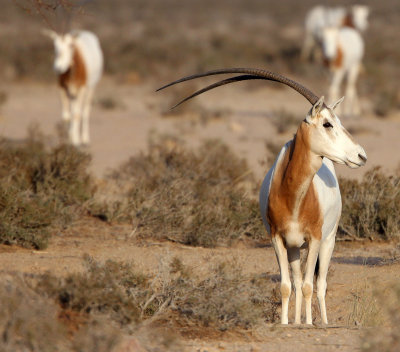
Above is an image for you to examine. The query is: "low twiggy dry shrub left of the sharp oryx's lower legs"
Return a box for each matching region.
[36,256,279,330]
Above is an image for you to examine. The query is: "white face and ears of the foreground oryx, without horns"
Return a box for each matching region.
[306,97,367,168]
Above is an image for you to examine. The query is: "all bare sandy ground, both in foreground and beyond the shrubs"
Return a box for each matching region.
[0,78,400,352]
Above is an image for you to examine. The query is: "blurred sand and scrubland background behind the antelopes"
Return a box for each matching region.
[0,0,400,180]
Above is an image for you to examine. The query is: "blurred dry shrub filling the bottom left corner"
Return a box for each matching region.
[0,274,133,352]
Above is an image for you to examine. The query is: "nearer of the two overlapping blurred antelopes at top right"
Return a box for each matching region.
[322,27,364,115]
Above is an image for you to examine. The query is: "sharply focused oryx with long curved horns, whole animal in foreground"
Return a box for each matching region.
[160,68,367,324]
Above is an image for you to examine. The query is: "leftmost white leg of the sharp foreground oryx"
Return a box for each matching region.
[272,235,292,324]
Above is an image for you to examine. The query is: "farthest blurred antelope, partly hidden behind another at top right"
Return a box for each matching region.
[301,5,369,60]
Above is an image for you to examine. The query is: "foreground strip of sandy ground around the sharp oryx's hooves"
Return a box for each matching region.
[0,219,400,352]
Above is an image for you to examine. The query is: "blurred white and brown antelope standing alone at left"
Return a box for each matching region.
[44,30,103,146]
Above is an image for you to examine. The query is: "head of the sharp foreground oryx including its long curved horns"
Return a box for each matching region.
[158,68,367,168]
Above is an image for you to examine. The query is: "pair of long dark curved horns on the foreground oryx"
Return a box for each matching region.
[157,68,319,106]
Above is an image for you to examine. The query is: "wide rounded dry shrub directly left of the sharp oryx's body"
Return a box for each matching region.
[92,137,264,247]
